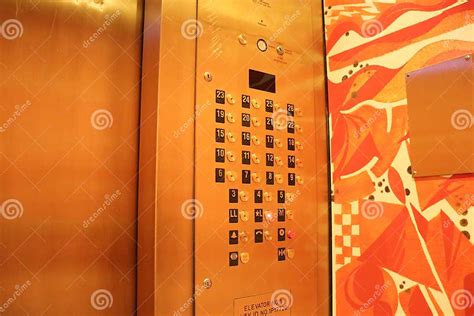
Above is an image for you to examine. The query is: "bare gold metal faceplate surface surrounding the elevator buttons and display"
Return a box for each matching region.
[195,0,329,315]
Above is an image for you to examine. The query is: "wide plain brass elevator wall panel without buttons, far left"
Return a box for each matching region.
[0,0,142,316]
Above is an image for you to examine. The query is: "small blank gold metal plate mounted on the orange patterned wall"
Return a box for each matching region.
[406,55,474,177]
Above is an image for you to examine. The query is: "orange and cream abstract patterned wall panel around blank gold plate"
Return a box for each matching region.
[325,0,474,316]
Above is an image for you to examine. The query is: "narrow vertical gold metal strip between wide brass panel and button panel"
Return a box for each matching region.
[138,0,196,315]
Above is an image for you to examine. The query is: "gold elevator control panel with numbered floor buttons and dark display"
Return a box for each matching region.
[195,0,326,315]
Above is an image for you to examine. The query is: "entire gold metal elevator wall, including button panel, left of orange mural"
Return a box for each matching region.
[0,0,331,315]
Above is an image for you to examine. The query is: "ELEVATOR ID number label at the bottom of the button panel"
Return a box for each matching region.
[234,293,291,316]
